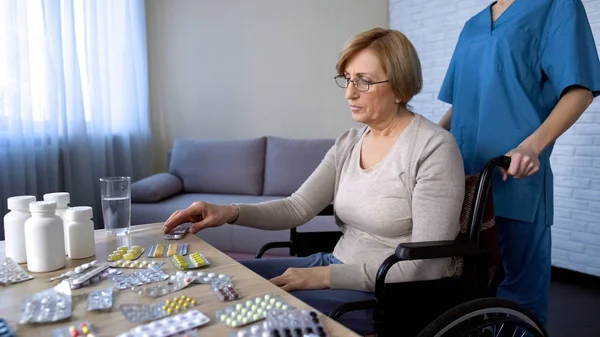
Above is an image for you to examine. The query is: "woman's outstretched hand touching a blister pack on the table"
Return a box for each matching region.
[163,201,239,234]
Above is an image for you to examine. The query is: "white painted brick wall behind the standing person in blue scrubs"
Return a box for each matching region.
[390,0,600,276]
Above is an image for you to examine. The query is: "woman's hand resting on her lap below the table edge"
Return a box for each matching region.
[270,267,330,291]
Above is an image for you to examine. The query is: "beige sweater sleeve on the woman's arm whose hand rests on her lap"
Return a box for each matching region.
[330,131,465,292]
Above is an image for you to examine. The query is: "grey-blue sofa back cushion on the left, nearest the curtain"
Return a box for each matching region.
[169,137,266,195]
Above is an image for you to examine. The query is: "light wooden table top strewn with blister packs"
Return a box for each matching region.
[0,223,358,337]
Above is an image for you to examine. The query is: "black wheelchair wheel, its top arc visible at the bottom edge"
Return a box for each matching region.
[417,298,548,337]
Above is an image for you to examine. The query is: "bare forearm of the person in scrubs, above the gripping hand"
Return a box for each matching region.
[522,88,594,155]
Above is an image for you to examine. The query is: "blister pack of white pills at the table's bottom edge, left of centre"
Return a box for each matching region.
[117,310,210,337]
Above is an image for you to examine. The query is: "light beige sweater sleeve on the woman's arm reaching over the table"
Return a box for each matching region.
[234,145,336,230]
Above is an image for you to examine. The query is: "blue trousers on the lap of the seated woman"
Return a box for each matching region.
[240,253,375,335]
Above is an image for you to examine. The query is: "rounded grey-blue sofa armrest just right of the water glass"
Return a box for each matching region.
[131,172,183,203]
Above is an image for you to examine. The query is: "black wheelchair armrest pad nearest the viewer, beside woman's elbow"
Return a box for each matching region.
[396,240,483,261]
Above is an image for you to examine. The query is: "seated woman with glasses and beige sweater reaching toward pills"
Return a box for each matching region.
[164,29,465,334]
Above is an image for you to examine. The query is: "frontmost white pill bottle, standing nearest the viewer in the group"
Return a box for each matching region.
[25,201,66,273]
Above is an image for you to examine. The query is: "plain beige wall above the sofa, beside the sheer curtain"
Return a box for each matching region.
[146,0,389,171]
